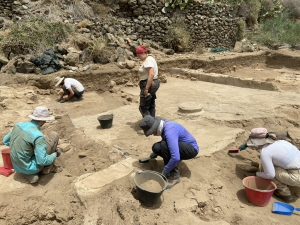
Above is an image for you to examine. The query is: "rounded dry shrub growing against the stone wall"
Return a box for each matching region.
[164,22,191,52]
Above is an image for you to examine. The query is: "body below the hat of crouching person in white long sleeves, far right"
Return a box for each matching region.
[256,140,300,202]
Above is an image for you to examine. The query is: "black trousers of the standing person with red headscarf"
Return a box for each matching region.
[139,79,160,117]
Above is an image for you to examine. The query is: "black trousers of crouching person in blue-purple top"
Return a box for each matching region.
[152,141,198,169]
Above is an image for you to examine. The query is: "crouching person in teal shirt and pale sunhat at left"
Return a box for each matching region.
[3,106,59,184]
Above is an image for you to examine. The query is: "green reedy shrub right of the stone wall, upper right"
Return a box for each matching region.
[252,12,300,48]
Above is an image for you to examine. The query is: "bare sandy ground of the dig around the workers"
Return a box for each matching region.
[0,50,300,225]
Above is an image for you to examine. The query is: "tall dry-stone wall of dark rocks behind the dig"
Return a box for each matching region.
[104,0,238,47]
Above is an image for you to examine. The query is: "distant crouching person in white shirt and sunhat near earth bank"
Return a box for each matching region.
[55,77,84,102]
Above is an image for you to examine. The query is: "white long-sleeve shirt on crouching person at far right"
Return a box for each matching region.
[256,140,300,179]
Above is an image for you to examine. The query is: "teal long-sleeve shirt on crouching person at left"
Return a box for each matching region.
[3,121,56,174]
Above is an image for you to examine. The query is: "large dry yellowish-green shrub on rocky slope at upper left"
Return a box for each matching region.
[0,18,72,55]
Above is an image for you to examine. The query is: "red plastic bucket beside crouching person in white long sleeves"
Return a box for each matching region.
[243,176,277,207]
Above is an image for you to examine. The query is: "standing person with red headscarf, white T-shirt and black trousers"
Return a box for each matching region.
[136,45,160,117]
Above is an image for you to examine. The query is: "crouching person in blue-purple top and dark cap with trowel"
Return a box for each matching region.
[140,115,199,186]
